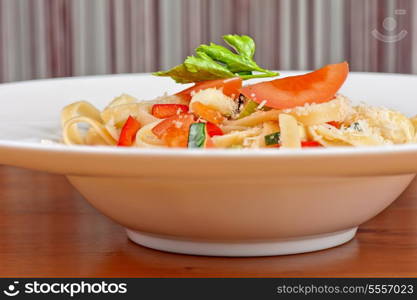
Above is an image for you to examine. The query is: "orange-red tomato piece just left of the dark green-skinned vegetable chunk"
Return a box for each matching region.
[152,114,194,147]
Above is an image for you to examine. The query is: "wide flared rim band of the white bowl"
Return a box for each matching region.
[0,70,417,176]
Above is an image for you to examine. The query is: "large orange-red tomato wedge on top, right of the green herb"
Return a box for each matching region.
[241,62,349,109]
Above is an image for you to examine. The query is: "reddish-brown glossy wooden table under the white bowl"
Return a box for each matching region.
[0,166,417,277]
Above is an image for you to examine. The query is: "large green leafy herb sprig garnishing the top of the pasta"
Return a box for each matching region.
[154,35,279,83]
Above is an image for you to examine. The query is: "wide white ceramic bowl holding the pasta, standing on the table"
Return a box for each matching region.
[0,72,417,256]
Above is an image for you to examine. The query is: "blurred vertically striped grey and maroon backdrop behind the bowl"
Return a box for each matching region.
[0,0,417,82]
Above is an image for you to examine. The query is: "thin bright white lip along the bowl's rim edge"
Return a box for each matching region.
[0,70,417,159]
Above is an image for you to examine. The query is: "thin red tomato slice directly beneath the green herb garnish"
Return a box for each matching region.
[175,77,242,101]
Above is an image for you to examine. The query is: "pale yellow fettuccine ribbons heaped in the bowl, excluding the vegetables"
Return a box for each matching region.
[61,89,417,149]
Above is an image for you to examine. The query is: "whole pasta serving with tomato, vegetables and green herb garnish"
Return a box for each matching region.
[61,35,417,149]
